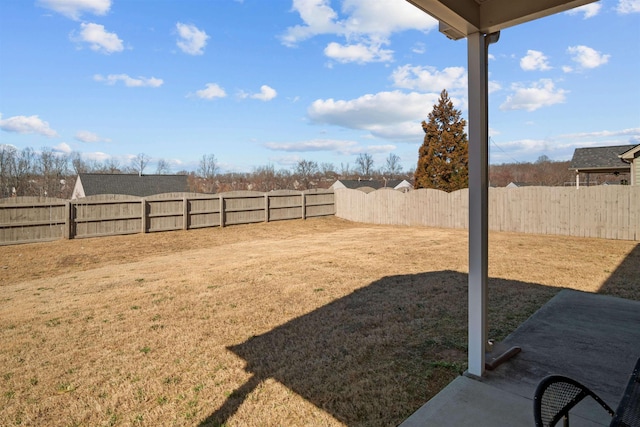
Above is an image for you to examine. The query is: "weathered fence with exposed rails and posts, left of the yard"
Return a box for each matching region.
[0,190,335,245]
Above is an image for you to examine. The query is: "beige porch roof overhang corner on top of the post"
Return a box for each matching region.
[407,0,597,40]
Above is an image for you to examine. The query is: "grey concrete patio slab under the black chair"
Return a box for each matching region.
[401,290,640,427]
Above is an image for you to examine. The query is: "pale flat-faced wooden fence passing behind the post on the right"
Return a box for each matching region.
[335,186,640,240]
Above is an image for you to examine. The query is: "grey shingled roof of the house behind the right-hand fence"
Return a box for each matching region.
[569,145,636,173]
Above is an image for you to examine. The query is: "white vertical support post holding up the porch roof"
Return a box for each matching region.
[467,33,489,377]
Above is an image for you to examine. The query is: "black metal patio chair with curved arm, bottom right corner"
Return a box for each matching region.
[533,359,640,427]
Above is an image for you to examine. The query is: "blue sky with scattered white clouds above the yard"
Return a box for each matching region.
[0,0,640,173]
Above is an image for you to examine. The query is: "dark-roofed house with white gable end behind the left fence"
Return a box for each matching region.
[72,173,189,199]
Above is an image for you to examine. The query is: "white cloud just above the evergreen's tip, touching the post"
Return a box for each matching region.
[391,65,467,92]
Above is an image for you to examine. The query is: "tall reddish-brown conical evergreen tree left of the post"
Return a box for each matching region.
[414,90,469,192]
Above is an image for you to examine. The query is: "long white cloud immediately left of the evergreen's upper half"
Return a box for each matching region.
[307,91,439,140]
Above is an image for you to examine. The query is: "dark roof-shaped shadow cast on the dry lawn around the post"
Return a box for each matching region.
[201,271,560,426]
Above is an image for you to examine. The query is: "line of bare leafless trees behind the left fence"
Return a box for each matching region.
[0,145,413,199]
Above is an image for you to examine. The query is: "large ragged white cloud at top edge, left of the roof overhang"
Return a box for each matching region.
[280,0,437,63]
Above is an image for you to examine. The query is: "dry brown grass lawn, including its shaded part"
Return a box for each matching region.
[0,217,640,426]
